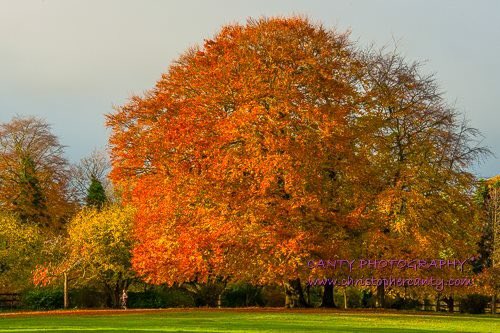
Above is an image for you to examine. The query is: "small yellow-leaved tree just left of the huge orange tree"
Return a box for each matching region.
[34,205,135,307]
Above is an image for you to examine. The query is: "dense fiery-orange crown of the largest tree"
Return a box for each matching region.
[108,18,368,304]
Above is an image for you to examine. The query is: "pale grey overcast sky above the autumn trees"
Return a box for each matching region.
[0,0,500,177]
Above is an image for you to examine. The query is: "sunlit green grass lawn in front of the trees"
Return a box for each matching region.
[0,309,500,333]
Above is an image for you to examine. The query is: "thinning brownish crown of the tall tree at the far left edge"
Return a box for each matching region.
[0,117,73,227]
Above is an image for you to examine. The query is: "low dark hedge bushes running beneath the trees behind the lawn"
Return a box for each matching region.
[11,284,489,313]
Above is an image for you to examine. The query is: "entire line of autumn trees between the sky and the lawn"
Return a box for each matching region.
[0,18,499,309]
